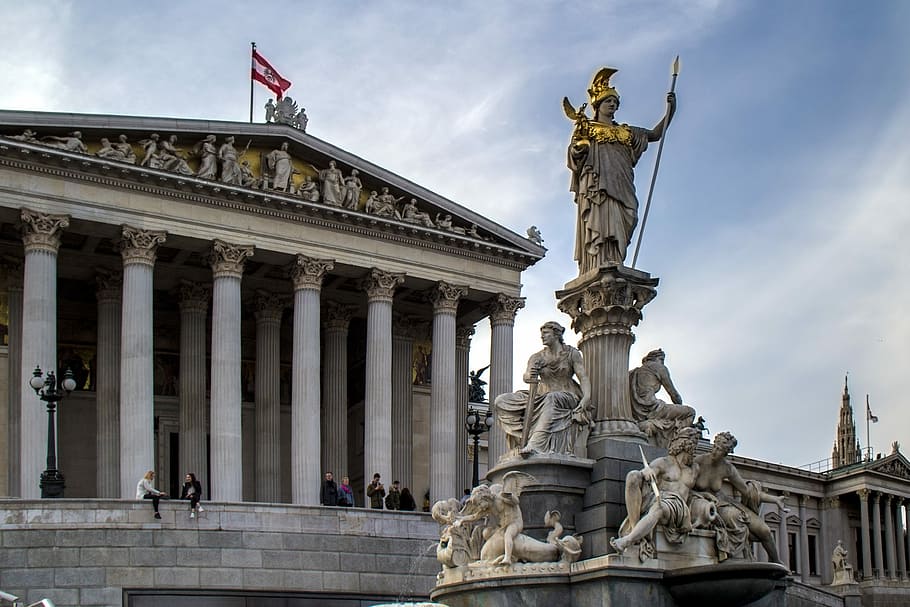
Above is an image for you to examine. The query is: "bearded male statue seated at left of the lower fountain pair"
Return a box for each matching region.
[610,428,701,561]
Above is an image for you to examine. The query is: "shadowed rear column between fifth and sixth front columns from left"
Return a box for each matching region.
[389,313,414,487]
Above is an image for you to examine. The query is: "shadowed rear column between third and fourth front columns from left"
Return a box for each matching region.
[255,291,285,502]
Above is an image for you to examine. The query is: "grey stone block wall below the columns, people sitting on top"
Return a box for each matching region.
[0,499,439,607]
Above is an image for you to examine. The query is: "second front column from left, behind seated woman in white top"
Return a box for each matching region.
[120,226,166,499]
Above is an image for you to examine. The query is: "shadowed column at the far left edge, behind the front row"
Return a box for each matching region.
[3,259,23,497]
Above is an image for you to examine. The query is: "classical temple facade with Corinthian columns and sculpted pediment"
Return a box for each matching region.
[0,112,545,505]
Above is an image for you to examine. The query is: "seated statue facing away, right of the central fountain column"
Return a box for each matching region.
[629,350,695,447]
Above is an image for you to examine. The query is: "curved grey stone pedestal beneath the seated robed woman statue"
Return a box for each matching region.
[486,454,594,541]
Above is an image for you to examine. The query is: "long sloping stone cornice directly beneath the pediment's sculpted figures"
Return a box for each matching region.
[0,138,543,271]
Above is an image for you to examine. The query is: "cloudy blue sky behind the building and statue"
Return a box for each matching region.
[0,0,910,466]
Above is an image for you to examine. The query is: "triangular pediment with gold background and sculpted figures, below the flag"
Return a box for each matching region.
[0,111,546,268]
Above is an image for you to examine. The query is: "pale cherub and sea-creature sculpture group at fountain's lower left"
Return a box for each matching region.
[433,470,581,567]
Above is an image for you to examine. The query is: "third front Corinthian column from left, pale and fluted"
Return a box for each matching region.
[210,240,253,502]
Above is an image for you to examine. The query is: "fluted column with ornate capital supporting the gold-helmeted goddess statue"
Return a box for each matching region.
[556,266,658,449]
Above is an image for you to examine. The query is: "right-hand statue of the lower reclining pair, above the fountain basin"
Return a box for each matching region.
[692,432,789,564]
